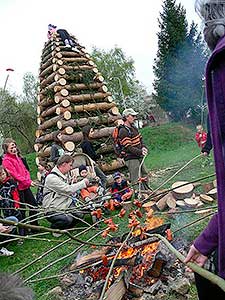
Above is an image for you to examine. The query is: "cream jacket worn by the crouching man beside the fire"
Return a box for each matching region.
[42,167,87,212]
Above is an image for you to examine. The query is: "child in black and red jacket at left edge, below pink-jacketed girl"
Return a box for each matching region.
[0,166,22,221]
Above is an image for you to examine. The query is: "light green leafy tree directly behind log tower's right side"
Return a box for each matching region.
[91,47,138,109]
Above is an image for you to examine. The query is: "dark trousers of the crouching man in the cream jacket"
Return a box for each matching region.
[46,212,76,229]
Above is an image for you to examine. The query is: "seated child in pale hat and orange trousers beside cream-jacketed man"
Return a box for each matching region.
[77,165,104,202]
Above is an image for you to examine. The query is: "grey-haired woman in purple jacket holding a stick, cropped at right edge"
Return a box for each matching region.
[186,0,225,300]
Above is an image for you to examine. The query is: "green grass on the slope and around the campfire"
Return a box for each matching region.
[0,123,214,300]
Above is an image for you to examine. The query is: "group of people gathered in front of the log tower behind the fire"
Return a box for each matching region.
[0,109,147,252]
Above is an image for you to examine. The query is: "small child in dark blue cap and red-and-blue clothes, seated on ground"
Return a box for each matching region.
[111,172,133,202]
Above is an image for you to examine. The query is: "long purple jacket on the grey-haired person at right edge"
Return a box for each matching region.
[194,36,225,278]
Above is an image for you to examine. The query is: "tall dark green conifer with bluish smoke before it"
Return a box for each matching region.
[154,0,206,120]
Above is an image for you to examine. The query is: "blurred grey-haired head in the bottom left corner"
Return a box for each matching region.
[0,272,34,300]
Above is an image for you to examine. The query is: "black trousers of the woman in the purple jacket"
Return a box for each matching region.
[195,273,225,300]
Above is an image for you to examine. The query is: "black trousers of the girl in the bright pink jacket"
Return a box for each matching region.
[19,188,38,226]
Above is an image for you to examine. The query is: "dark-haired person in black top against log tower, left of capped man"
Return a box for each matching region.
[80,125,107,189]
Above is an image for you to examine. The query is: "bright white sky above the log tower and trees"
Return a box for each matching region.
[0,0,200,93]
